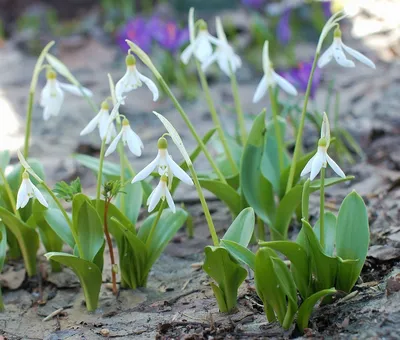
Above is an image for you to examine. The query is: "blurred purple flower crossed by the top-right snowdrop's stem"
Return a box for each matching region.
[280,62,321,99]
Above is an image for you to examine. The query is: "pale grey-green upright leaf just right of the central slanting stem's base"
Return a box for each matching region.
[222,208,255,247]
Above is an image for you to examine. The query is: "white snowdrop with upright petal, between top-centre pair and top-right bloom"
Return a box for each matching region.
[253,40,297,103]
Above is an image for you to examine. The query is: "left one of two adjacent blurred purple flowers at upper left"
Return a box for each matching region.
[117,17,152,53]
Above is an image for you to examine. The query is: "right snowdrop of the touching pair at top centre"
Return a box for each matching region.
[201,17,242,77]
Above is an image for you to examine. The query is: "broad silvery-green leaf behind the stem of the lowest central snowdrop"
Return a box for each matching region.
[138,208,188,270]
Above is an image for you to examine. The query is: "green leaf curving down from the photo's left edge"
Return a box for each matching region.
[0,207,39,276]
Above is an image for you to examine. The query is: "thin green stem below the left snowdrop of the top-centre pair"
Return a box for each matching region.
[196,61,238,173]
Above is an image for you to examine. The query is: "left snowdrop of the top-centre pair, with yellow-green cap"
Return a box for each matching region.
[181,7,220,65]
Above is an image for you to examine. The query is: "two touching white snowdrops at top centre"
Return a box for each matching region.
[181,8,242,77]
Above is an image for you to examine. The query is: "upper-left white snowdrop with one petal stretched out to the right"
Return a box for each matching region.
[40,70,92,120]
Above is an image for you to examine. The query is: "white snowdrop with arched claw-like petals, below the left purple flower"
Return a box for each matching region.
[115,54,159,104]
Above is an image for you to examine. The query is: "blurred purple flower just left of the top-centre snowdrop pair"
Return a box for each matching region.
[149,18,189,53]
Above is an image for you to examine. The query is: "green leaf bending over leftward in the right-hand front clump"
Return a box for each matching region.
[259,241,311,298]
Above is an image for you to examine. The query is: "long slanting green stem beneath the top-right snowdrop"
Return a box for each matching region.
[286,52,319,193]
